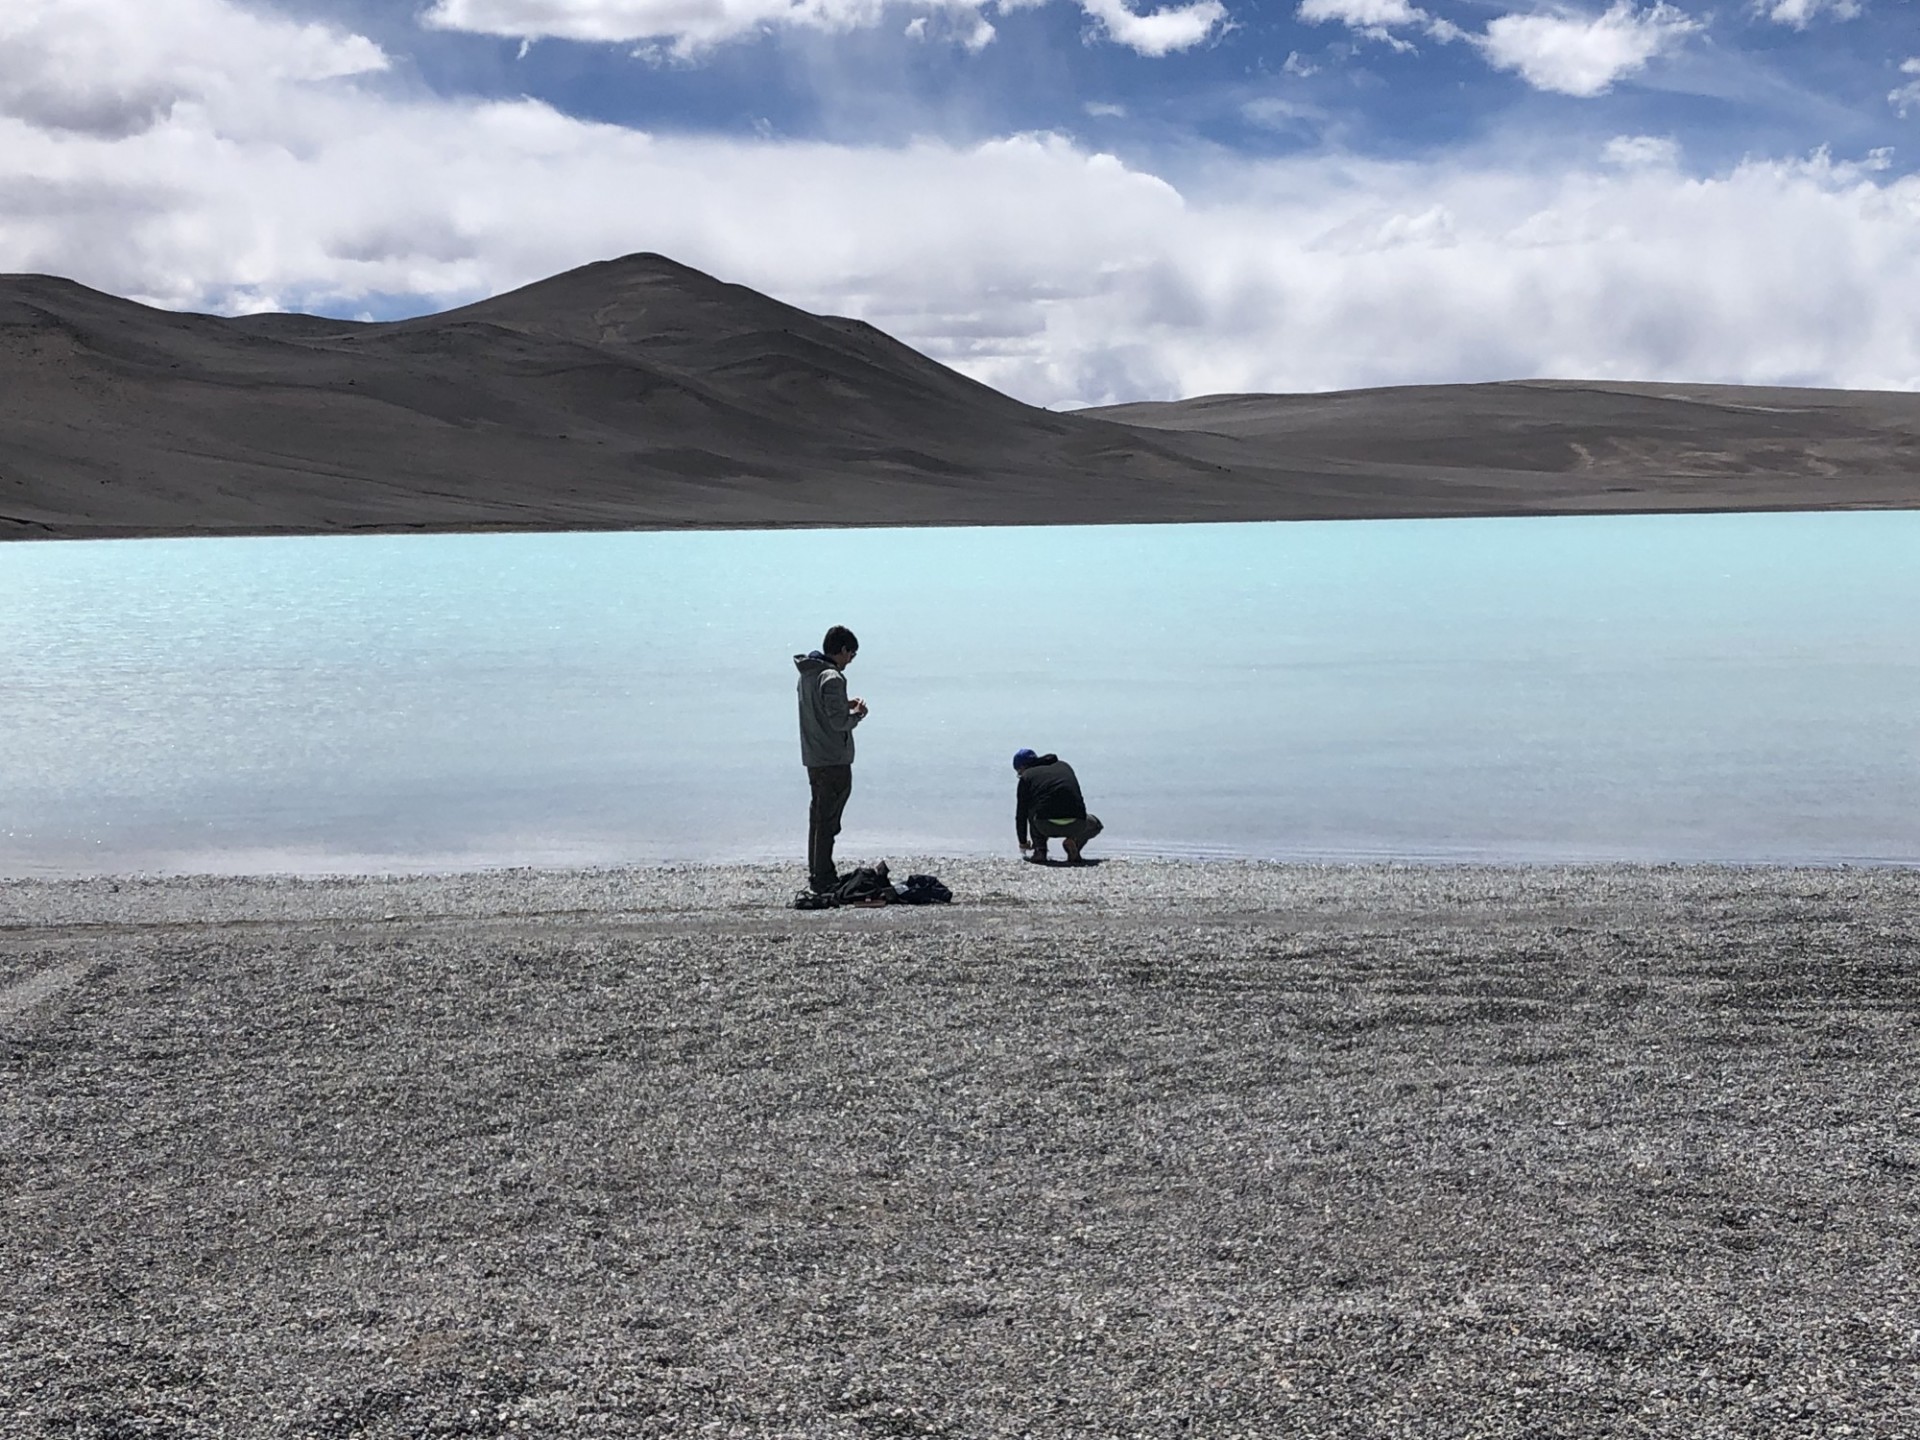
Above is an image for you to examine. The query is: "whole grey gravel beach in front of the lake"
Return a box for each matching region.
[0,860,1920,1440]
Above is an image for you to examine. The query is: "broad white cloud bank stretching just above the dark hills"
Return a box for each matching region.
[0,0,1920,403]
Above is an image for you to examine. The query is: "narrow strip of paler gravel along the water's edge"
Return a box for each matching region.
[0,854,1920,931]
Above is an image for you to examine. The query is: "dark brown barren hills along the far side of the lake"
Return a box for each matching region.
[0,255,1920,538]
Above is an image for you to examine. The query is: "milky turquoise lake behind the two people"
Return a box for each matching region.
[0,513,1920,876]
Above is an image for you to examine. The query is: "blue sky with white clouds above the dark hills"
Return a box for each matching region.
[0,0,1920,405]
